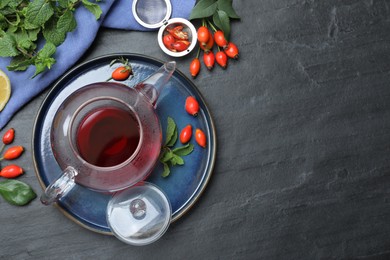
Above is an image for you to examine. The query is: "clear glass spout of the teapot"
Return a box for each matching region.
[134,61,176,106]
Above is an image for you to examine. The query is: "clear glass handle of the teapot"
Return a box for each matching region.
[40,166,77,205]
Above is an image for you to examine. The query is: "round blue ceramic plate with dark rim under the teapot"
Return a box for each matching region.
[32,53,216,234]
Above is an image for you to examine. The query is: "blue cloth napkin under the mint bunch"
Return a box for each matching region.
[0,0,195,129]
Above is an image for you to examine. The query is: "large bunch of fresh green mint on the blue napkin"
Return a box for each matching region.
[0,0,102,77]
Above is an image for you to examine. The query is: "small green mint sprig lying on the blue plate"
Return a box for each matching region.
[159,117,194,178]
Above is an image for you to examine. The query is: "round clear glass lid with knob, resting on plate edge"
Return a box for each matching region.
[106,182,172,246]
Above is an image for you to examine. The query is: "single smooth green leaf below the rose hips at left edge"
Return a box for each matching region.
[0,180,37,206]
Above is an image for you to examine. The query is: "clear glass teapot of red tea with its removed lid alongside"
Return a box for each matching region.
[40,61,176,245]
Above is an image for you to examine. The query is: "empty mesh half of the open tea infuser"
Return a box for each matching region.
[132,0,172,29]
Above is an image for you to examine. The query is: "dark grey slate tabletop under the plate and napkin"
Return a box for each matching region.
[0,0,390,259]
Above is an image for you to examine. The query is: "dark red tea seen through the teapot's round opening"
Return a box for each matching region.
[76,106,140,167]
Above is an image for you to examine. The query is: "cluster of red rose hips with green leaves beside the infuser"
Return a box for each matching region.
[189,0,240,78]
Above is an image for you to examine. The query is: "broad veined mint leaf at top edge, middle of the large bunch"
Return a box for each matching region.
[26,0,54,29]
